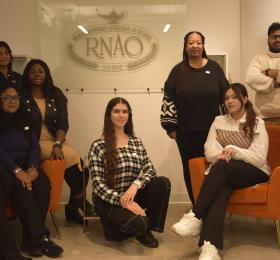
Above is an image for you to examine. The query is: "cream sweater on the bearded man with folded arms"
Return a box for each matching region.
[246,52,280,118]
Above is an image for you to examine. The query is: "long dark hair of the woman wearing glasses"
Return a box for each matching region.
[0,81,31,138]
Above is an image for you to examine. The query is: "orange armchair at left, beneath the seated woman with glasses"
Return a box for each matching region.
[5,160,65,239]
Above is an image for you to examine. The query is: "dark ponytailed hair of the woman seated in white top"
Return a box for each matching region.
[225,83,257,140]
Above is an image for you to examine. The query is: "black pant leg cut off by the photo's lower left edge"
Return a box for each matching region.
[0,166,17,259]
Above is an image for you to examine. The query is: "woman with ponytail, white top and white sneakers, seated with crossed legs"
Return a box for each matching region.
[172,83,270,260]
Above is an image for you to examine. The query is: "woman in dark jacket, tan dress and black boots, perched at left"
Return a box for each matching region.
[22,59,93,224]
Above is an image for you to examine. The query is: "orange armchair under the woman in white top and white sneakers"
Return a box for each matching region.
[189,125,280,245]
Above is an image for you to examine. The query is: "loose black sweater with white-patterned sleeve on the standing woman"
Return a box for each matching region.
[161,59,229,132]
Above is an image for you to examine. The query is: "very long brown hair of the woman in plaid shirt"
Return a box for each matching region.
[103,97,134,187]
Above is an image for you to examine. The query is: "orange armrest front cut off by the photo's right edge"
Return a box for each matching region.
[267,166,280,215]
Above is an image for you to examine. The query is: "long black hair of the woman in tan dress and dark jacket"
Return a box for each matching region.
[22,59,67,104]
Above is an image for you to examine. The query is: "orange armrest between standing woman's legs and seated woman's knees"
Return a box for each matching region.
[189,157,209,200]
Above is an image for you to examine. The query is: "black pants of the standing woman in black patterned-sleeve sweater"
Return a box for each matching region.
[177,131,208,205]
